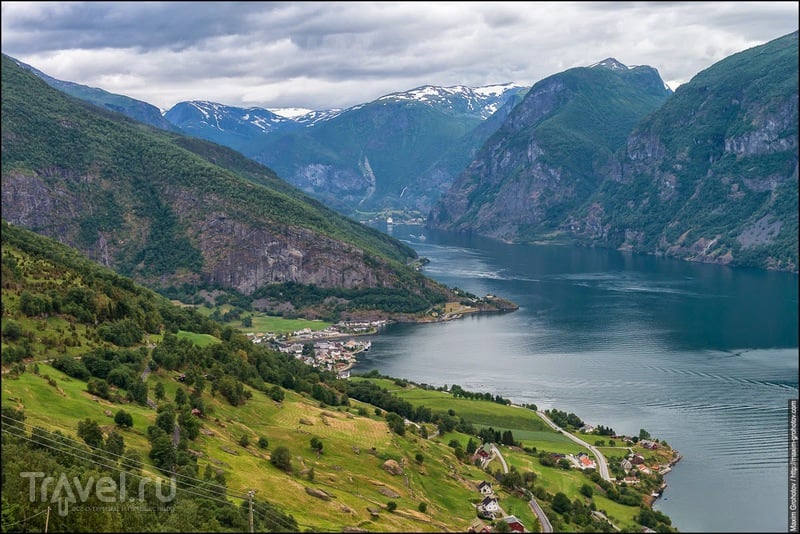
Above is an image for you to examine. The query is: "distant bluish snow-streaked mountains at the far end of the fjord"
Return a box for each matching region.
[165,84,526,218]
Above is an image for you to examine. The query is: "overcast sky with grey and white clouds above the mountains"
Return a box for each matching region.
[1,2,798,110]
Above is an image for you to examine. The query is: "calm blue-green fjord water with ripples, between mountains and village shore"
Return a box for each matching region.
[354,225,798,532]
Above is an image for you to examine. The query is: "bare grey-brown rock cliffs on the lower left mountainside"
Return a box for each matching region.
[2,165,410,295]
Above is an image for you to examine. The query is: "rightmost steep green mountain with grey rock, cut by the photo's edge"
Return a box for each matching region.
[574,32,798,272]
